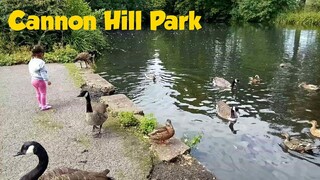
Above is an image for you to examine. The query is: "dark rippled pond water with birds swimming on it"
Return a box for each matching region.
[98,25,320,180]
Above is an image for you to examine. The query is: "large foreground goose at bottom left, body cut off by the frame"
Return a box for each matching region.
[14,141,111,180]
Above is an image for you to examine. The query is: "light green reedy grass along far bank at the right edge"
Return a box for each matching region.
[275,11,320,27]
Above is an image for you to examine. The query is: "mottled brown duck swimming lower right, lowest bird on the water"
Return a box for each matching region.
[281,133,317,153]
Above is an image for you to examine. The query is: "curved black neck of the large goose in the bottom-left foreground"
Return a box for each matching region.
[20,147,49,180]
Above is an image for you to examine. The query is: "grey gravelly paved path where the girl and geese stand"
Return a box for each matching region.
[0,64,150,180]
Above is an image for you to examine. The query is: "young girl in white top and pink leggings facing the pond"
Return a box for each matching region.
[28,45,51,111]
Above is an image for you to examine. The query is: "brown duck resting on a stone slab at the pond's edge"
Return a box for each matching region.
[148,119,175,143]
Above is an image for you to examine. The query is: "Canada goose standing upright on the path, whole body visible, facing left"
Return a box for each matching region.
[78,91,108,136]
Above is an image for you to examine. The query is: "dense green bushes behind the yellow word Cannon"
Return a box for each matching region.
[0,0,107,53]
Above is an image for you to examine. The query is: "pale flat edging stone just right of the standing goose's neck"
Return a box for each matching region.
[101,94,143,115]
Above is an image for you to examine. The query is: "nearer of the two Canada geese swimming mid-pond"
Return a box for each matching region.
[216,101,239,121]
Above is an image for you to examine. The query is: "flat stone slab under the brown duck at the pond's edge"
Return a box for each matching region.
[151,137,190,161]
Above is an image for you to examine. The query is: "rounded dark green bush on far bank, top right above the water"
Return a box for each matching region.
[231,0,298,22]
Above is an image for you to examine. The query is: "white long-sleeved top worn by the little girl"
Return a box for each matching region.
[28,57,49,81]
